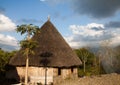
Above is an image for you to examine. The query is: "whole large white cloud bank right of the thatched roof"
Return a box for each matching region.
[65,23,120,48]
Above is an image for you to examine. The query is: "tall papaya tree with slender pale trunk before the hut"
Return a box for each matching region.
[16,24,39,85]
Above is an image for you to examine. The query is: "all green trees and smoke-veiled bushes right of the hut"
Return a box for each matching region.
[75,45,120,76]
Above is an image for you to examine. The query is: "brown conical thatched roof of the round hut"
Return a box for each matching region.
[9,20,81,67]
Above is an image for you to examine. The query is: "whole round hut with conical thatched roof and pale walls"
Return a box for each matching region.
[7,20,81,84]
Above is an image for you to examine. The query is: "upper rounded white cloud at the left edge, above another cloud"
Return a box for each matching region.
[0,14,16,32]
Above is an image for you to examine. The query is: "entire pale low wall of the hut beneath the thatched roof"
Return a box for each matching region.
[7,67,78,84]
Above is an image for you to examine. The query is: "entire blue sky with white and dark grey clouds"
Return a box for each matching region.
[0,0,120,50]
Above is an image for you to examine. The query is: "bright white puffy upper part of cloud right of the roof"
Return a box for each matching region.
[70,23,104,36]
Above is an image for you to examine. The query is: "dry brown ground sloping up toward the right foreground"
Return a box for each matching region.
[57,73,120,85]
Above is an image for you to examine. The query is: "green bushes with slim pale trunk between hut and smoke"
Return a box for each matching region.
[75,48,104,76]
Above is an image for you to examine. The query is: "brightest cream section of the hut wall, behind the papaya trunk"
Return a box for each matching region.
[17,67,53,84]
